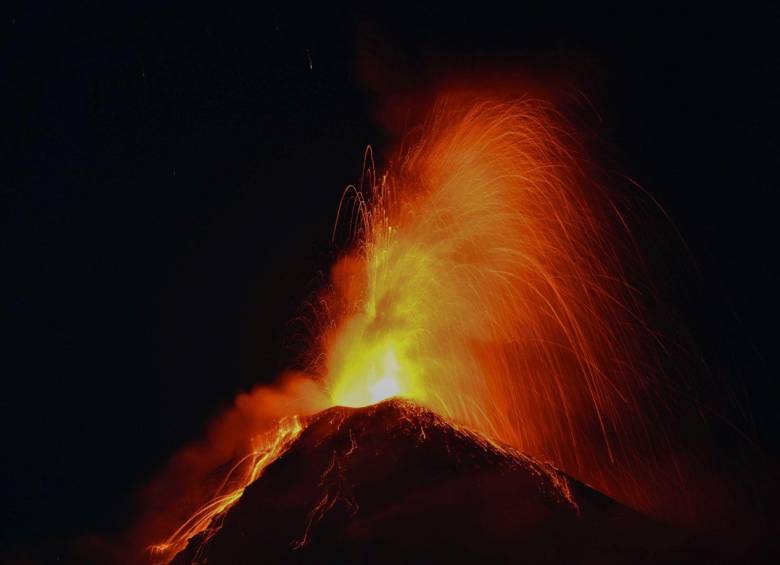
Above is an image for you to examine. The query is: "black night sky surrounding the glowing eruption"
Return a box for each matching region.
[0,3,780,560]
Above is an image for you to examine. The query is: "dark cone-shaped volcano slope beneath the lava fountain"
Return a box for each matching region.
[174,399,701,564]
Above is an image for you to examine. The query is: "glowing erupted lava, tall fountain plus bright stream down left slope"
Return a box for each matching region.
[149,96,684,556]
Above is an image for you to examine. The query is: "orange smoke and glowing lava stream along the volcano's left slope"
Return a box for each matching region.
[134,373,330,563]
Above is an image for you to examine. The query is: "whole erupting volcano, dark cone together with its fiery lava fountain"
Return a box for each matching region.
[143,99,701,564]
